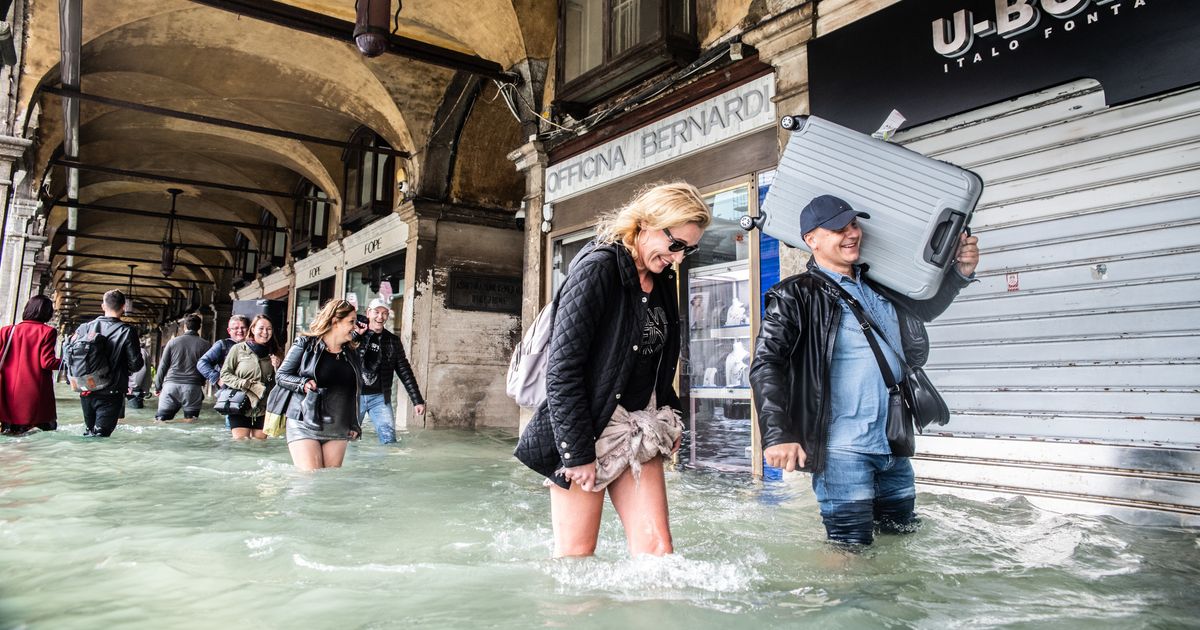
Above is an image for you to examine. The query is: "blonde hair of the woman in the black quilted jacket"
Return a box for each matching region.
[596,181,713,258]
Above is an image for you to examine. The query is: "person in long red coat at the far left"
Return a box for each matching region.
[0,295,60,436]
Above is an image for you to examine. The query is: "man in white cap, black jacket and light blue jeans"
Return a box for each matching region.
[359,298,425,444]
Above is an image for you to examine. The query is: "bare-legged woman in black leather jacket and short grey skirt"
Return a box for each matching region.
[280,300,366,470]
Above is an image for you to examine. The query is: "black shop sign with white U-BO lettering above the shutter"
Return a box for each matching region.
[809,0,1200,132]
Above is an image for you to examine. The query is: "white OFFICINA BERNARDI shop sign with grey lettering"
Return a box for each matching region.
[546,74,775,203]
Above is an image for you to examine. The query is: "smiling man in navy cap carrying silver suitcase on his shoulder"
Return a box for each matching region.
[750,194,979,545]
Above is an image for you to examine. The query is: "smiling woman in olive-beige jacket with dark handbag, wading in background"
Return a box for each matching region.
[221,314,278,439]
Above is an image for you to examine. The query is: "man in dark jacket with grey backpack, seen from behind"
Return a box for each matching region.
[64,289,145,438]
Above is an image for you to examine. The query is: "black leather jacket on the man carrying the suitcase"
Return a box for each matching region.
[750,259,970,473]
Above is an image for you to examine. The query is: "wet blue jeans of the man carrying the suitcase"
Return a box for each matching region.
[812,449,919,545]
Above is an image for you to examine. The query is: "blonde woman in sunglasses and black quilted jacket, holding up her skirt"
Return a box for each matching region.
[515,182,712,557]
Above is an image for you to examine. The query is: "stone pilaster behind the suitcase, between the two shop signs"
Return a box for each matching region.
[742,1,816,277]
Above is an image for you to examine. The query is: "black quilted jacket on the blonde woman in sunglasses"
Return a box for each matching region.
[514,242,679,488]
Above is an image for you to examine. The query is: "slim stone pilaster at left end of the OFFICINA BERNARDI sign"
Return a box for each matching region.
[508,142,550,431]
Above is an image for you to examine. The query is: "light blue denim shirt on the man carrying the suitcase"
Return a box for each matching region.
[817,265,904,455]
